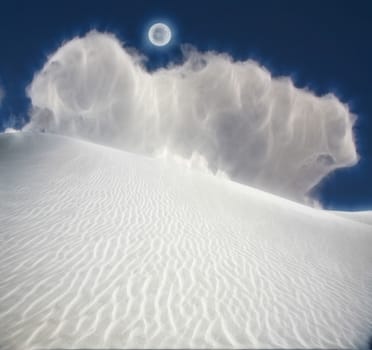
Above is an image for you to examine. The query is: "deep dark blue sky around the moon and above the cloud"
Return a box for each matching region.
[0,0,372,210]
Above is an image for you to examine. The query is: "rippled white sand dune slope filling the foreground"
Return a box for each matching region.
[0,133,372,350]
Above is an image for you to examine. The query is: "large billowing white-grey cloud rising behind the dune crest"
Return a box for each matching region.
[26,32,357,202]
